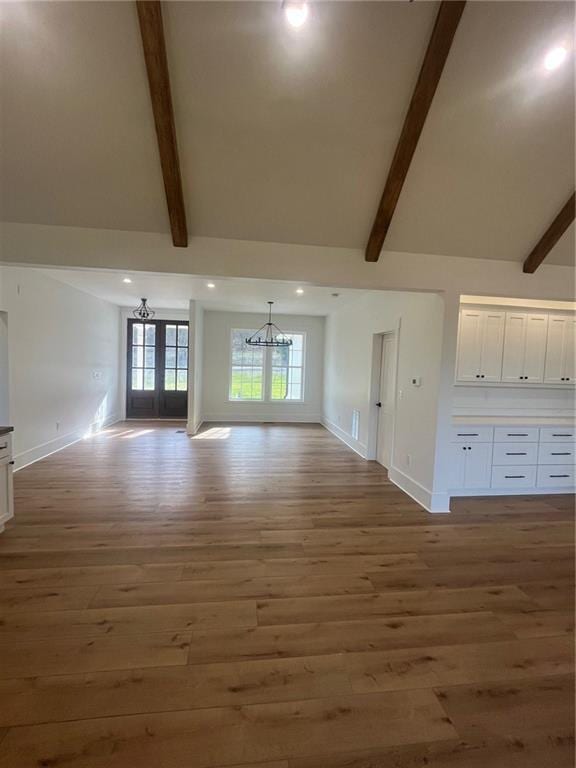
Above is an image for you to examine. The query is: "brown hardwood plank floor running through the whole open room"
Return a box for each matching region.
[0,422,574,768]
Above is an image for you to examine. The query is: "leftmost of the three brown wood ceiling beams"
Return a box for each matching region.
[136,0,188,248]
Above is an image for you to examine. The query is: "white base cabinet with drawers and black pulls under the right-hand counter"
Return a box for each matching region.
[449,424,576,496]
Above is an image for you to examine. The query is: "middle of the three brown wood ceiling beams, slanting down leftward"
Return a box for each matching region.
[366,0,466,261]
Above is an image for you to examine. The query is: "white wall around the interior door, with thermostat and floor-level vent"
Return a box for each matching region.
[324,292,443,503]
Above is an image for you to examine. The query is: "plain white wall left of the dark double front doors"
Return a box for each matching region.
[0,267,120,468]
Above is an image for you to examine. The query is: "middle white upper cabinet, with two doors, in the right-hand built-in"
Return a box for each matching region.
[501,312,548,384]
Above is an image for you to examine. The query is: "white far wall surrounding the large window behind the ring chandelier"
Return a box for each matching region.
[202,311,324,421]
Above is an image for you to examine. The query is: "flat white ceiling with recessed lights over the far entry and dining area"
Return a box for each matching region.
[39,269,363,315]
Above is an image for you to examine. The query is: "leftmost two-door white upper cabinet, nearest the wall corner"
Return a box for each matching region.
[457,309,505,382]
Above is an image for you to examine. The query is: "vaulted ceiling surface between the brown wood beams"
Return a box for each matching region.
[0,0,574,264]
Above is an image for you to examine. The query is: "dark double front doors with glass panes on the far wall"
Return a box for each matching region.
[126,320,188,419]
